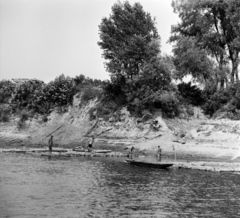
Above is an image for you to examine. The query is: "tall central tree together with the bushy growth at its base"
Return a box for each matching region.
[98,1,182,116]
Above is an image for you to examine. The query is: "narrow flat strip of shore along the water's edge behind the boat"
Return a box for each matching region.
[0,147,240,173]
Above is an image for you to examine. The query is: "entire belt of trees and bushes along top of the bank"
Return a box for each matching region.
[0,0,240,122]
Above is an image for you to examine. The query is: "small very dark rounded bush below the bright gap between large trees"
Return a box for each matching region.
[178,82,205,106]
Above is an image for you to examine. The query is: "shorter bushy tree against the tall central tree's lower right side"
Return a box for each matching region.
[124,58,171,114]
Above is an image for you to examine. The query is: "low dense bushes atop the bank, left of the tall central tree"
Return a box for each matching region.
[0,75,103,122]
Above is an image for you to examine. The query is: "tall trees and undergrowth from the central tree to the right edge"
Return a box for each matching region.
[98,0,240,119]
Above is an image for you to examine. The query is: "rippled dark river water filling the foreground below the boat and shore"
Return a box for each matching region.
[0,154,240,218]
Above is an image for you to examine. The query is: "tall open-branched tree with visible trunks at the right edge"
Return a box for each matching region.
[172,0,240,85]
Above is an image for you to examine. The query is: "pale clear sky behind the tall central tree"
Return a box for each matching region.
[0,0,178,82]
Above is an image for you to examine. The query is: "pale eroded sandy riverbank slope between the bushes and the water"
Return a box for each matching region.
[0,99,240,172]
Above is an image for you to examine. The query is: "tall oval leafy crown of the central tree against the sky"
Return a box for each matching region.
[98,1,160,81]
